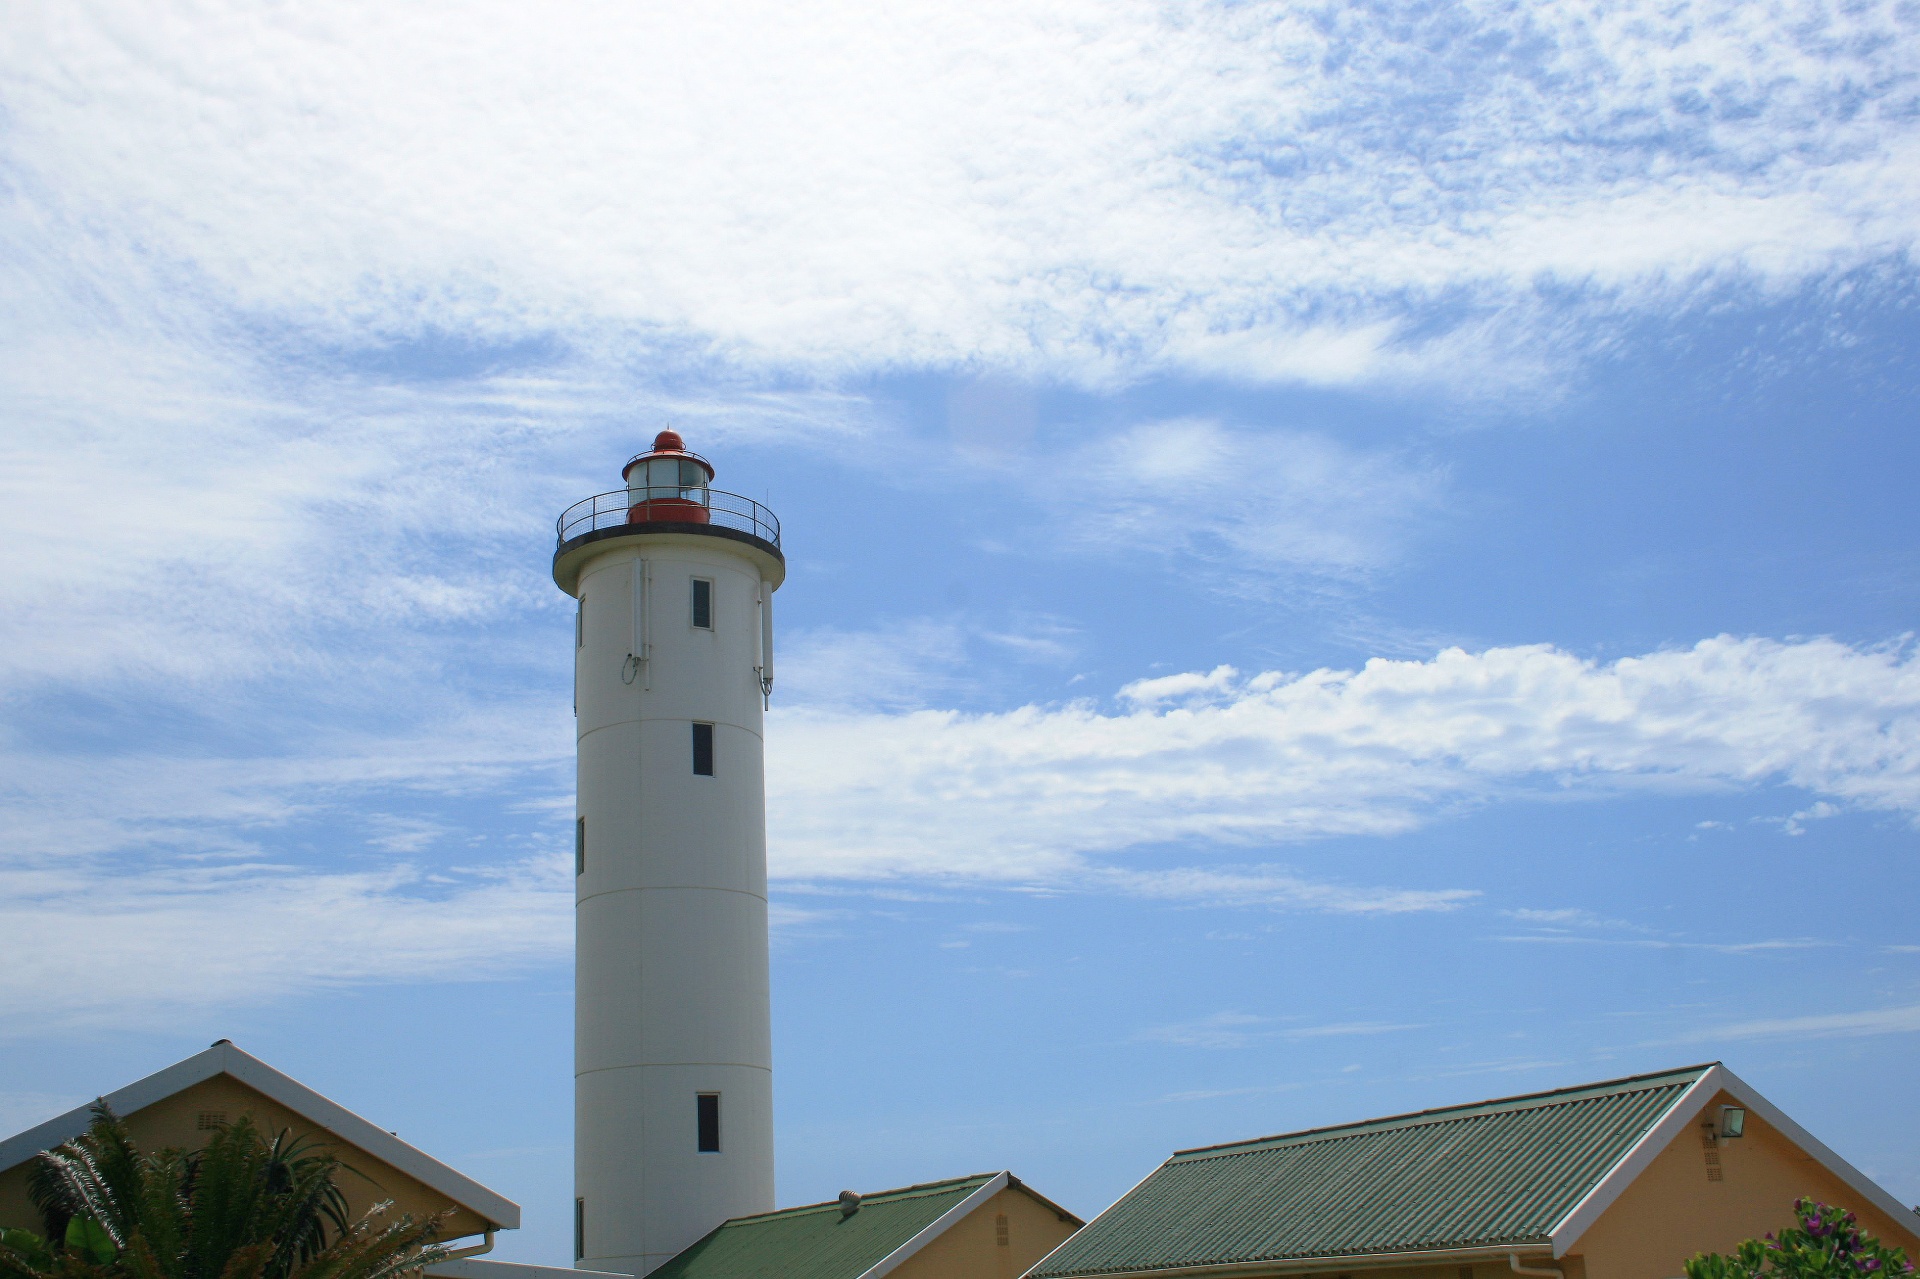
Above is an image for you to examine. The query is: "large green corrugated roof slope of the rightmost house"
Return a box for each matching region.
[1029,1066,1709,1279]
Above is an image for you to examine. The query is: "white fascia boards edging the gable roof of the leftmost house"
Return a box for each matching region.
[0,1041,520,1231]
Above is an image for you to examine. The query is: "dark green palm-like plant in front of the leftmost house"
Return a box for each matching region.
[0,1102,445,1279]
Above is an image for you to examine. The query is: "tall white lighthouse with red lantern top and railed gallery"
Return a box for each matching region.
[553,430,785,1275]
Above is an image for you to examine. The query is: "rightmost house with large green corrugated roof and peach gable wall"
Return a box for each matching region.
[1031,1064,1920,1279]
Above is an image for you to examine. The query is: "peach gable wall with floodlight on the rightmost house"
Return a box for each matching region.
[1572,1093,1920,1279]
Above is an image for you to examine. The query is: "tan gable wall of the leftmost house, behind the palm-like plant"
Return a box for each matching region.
[0,1075,486,1239]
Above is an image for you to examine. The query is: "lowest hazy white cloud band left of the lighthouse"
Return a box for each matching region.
[0,855,572,1035]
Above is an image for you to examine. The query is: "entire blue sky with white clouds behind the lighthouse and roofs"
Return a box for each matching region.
[0,0,1920,1264]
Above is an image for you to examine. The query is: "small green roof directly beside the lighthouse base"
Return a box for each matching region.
[649,1173,998,1279]
